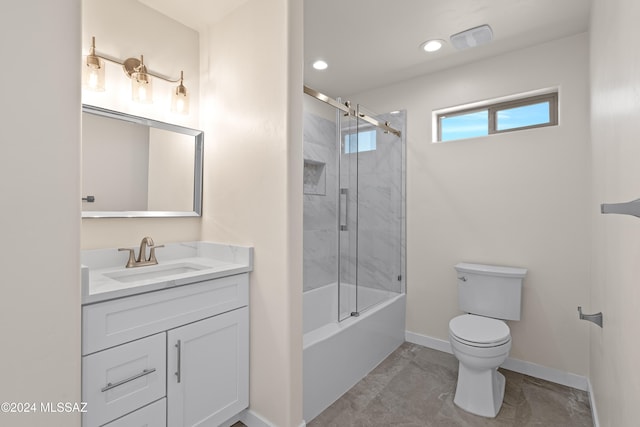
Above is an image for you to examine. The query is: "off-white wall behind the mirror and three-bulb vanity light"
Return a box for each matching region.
[82,0,202,249]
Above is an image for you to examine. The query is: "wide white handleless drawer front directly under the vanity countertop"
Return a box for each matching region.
[82,273,249,355]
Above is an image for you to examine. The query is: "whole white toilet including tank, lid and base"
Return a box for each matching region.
[449,263,527,418]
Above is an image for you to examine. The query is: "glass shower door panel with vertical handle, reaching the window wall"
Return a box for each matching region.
[337,105,404,320]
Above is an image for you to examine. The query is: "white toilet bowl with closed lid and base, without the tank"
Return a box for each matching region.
[449,314,511,418]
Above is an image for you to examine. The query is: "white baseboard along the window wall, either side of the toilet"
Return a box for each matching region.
[405,331,589,391]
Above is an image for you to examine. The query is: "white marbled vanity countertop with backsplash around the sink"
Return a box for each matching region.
[82,242,253,305]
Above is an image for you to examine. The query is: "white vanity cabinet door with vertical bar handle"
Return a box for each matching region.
[167,307,249,427]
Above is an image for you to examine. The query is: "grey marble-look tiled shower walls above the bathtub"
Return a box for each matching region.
[304,108,406,292]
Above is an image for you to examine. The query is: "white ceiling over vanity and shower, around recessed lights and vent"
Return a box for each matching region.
[139,0,591,97]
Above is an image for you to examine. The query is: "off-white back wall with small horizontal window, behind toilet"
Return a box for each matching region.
[350,34,594,376]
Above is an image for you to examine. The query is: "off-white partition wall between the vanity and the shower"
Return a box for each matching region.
[200,0,302,427]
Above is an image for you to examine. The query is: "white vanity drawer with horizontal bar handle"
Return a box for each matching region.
[82,332,167,427]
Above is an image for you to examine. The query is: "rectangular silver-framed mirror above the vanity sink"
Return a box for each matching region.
[82,105,204,218]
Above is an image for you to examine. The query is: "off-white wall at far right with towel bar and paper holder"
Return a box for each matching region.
[589,0,640,427]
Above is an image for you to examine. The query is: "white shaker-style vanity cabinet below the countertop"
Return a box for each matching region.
[82,273,249,427]
